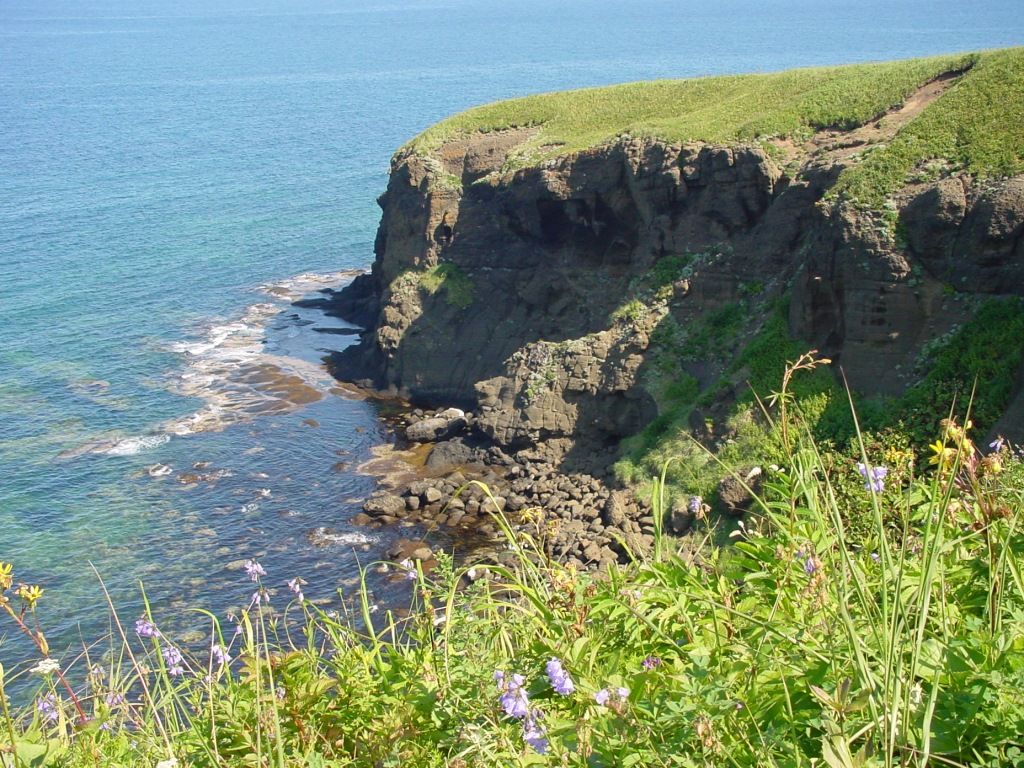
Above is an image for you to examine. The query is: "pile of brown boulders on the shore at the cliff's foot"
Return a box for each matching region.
[353,409,655,568]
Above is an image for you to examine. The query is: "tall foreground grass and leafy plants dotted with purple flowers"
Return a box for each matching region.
[0,405,1024,768]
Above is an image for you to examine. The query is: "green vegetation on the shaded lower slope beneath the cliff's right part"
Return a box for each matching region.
[615,298,1024,514]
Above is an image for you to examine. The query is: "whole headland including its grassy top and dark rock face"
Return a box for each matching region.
[333,49,1024,471]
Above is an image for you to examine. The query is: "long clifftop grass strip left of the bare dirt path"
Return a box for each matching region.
[408,51,974,160]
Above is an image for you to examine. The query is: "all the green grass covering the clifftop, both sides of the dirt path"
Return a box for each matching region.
[406,48,1024,203]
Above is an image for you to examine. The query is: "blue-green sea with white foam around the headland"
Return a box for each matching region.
[0,0,1024,679]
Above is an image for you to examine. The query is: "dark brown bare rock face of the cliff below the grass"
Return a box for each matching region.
[334,83,1024,468]
